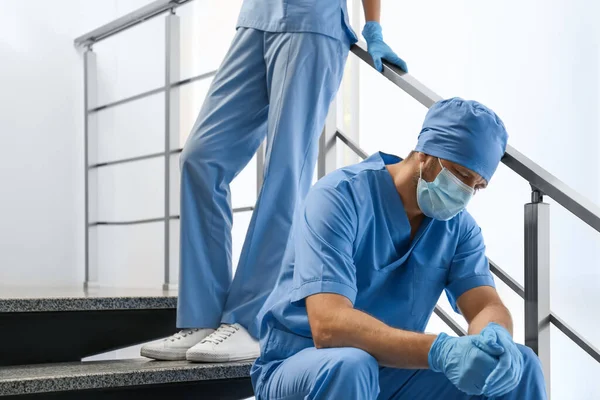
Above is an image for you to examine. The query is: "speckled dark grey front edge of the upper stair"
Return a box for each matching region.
[0,296,177,313]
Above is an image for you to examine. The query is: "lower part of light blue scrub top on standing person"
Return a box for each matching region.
[237,0,358,43]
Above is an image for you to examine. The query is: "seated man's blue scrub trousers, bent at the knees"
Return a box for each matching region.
[255,345,547,400]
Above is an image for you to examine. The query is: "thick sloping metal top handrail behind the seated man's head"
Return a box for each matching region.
[350,43,600,232]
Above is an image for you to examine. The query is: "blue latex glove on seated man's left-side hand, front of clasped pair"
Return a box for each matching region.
[428,333,501,396]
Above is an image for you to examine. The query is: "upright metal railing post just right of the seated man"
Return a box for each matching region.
[525,188,550,398]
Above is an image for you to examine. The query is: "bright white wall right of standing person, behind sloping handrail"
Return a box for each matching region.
[352,0,600,399]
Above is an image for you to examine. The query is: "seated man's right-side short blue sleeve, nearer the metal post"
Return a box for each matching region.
[446,214,495,314]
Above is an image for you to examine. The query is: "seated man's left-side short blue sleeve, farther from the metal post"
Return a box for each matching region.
[291,187,357,304]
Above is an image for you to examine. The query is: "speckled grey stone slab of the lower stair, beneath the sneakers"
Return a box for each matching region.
[0,361,252,397]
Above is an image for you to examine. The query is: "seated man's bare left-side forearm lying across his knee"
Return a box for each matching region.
[315,308,436,369]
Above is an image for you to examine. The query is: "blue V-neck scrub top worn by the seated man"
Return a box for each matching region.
[252,152,494,379]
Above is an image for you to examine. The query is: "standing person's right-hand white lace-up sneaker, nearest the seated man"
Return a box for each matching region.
[186,324,260,362]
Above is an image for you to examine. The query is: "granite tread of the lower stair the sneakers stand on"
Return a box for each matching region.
[0,358,252,396]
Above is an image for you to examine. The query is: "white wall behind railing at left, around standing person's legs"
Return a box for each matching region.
[0,0,251,287]
